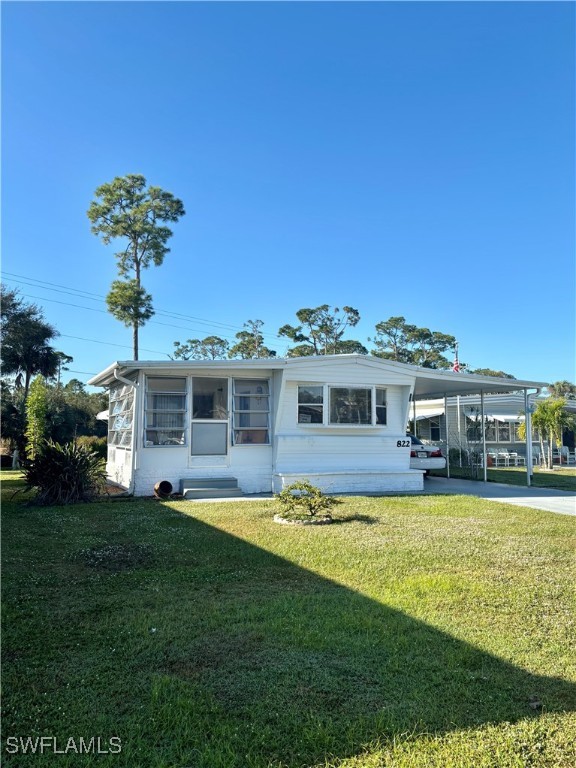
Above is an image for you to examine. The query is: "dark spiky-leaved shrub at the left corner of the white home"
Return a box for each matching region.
[24,440,106,505]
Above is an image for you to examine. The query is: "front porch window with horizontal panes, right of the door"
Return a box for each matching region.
[232,379,270,445]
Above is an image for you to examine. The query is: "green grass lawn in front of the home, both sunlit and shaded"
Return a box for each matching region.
[2,472,576,768]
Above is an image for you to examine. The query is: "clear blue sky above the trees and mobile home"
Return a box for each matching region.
[2,2,576,381]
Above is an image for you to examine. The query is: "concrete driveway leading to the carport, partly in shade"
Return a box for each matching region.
[424,477,576,516]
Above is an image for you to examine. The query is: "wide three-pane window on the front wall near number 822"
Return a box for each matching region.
[298,384,386,426]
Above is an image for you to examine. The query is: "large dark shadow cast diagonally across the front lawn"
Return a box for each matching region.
[4,502,576,768]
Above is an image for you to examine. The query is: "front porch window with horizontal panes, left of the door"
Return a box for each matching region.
[144,376,186,447]
